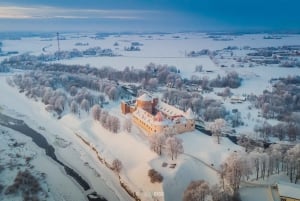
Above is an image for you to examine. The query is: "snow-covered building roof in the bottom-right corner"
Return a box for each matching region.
[277,182,300,200]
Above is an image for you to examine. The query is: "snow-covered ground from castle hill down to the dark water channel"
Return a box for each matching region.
[0,73,239,200]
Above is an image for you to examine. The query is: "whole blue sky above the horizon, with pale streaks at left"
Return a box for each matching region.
[0,0,300,32]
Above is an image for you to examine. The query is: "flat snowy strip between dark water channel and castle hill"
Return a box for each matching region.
[0,76,131,201]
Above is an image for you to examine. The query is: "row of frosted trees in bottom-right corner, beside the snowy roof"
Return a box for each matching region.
[183,144,300,201]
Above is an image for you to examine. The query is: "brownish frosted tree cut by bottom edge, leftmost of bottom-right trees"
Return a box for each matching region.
[183,180,209,201]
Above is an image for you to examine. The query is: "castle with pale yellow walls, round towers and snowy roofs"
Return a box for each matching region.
[121,94,195,135]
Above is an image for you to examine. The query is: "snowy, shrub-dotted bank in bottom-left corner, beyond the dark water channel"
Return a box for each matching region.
[0,125,87,201]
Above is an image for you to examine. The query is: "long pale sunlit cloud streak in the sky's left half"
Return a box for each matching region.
[0,6,158,20]
